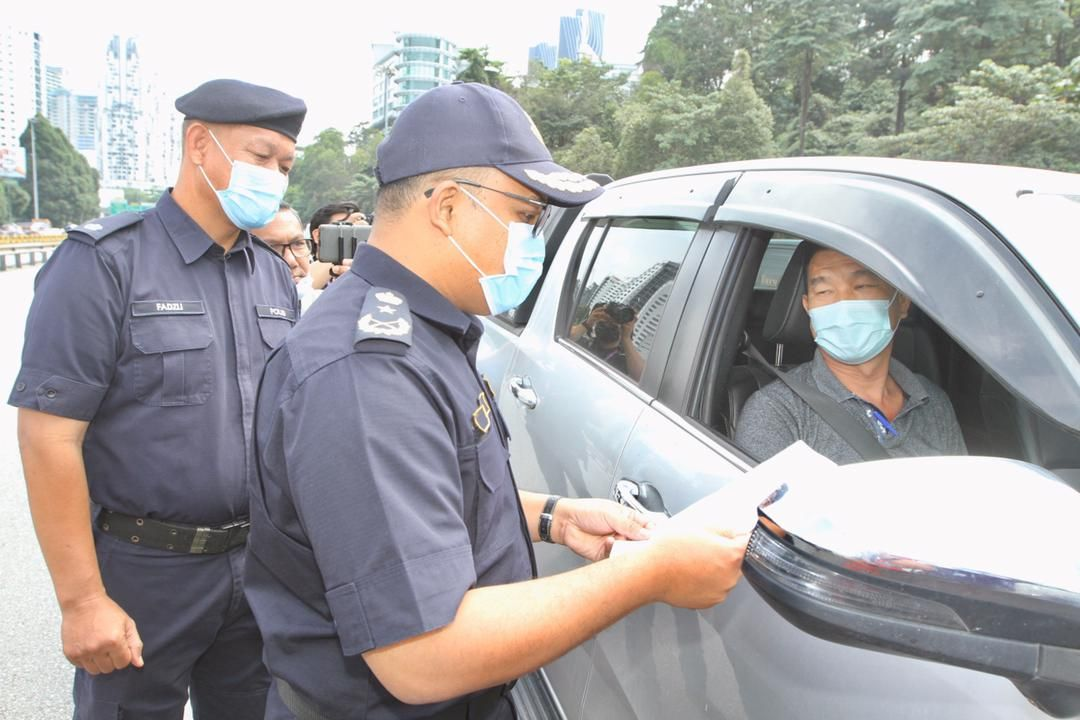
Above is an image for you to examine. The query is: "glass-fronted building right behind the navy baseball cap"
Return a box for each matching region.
[372,32,458,127]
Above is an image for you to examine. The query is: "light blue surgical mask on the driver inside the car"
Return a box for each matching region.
[808,291,899,365]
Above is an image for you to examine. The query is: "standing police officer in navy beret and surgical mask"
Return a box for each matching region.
[8,80,306,720]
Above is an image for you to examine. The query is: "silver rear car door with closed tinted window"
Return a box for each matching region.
[497,207,707,720]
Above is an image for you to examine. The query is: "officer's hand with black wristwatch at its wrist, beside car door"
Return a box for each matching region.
[551,498,653,560]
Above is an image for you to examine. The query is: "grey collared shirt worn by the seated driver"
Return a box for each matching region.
[735,350,968,465]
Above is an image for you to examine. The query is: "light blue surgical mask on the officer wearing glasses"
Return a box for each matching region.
[447,188,544,315]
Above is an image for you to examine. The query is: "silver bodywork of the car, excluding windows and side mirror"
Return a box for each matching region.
[482,159,1080,720]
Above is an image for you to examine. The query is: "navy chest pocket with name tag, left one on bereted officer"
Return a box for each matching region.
[131,302,214,407]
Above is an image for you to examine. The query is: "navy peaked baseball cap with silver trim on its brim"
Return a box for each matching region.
[375,82,604,207]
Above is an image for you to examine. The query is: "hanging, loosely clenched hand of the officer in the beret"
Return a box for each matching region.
[60,595,143,675]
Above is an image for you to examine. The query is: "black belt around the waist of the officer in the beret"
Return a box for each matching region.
[97,508,251,555]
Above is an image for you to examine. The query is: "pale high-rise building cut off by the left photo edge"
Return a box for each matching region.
[0,26,46,177]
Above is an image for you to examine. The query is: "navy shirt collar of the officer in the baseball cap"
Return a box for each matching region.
[351,244,481,342]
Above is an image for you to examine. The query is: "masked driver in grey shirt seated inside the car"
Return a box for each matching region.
[735,248,967,464]
